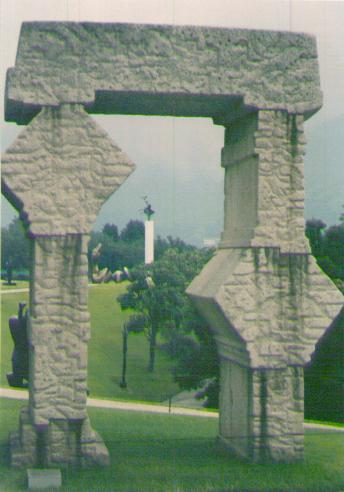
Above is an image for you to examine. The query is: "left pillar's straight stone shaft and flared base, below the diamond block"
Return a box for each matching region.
[7,234,109,467]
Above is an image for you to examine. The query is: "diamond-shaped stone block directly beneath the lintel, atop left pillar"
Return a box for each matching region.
[2,104,134,235]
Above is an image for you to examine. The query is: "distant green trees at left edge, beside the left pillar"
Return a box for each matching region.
[1,218,30,270]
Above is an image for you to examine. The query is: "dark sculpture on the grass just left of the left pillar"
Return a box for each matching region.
[7,302,29,388]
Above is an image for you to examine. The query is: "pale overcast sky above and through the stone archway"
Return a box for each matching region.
[0,0,344,242]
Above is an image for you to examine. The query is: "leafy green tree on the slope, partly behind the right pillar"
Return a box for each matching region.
[118,247,218,389]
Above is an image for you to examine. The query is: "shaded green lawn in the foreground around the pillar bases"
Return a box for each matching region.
[0,399,344,492]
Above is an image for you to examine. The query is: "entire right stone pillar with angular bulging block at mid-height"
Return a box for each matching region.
[188,107,343,462]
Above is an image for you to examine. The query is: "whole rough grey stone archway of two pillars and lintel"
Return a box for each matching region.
[2,22,342,466]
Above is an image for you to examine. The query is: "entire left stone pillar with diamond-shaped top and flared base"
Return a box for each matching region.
[2,104,133,466]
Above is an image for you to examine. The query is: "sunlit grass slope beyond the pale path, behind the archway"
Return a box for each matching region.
[0,282,178,402]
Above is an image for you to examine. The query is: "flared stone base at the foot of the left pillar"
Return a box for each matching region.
[10,407,110,468]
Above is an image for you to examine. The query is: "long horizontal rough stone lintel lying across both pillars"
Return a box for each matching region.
[6,22,322,122]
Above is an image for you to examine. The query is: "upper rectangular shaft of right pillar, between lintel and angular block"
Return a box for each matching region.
[222,111,310,254]
